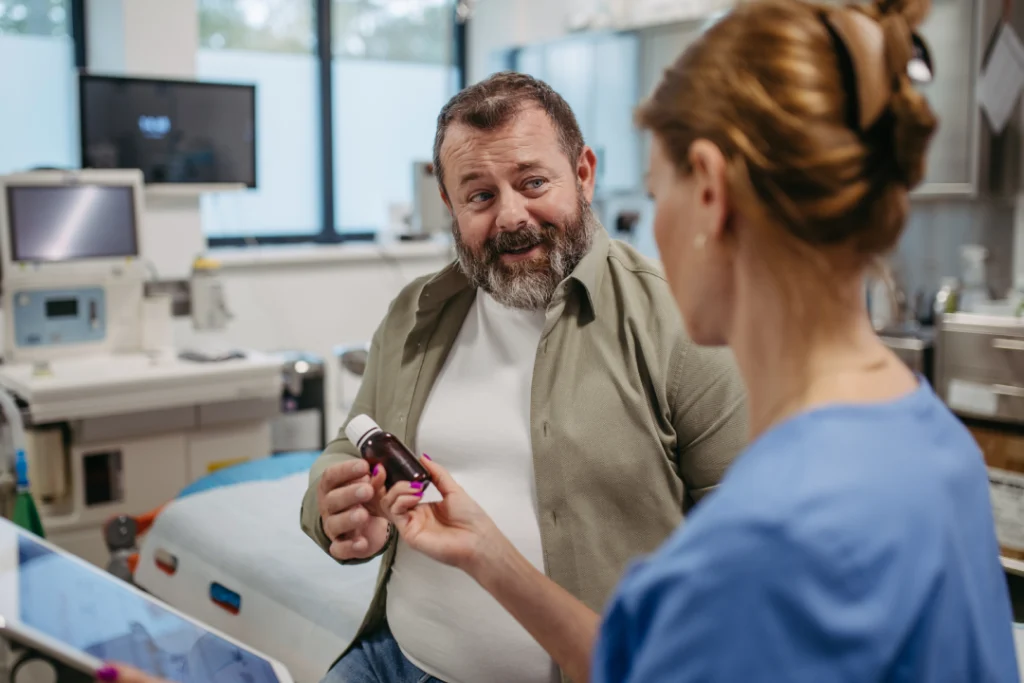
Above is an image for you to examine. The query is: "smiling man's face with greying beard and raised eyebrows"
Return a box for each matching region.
[441,106,597,309]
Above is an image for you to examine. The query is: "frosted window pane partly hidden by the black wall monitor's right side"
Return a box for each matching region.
[196,0,323,240]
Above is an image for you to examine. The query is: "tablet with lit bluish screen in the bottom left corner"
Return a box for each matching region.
[0,519,293,683]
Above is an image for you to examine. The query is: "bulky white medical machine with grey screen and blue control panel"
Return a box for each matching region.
[0,170,282,565]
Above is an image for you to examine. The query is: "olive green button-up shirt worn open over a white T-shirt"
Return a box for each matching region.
[301,229,746,675]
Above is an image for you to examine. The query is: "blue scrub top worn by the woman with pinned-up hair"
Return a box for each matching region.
[593,381,1018,683]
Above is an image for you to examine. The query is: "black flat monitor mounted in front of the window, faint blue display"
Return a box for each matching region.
[79,75,256,187]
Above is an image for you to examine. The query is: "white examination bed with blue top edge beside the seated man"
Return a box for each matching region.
[134,453,378,683]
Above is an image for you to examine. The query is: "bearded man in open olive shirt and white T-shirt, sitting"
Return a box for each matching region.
[302,74,746,683]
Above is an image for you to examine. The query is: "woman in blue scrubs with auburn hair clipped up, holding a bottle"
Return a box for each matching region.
[374,0,1018,683]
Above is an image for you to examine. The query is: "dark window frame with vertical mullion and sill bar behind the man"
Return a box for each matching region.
[194,0,468,248]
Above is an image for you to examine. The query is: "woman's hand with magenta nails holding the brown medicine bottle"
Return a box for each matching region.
[372,456,509,575]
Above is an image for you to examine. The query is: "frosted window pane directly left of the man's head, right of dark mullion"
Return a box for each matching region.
[332,0,459,232]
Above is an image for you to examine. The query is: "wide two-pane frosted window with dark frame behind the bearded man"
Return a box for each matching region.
[195,0,462,245]
